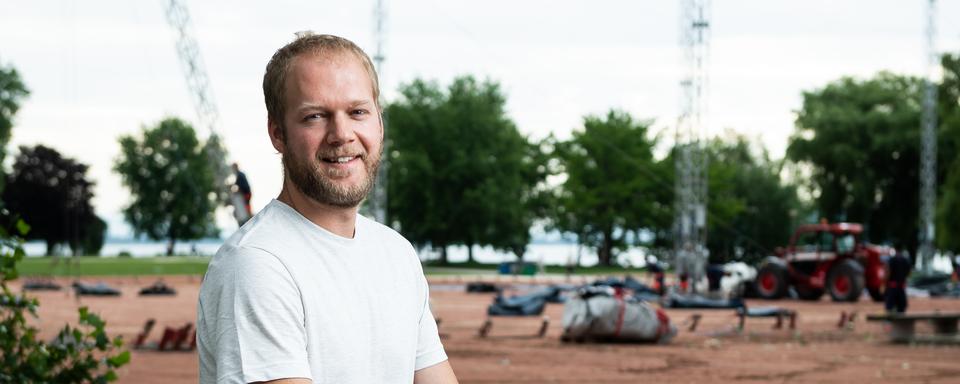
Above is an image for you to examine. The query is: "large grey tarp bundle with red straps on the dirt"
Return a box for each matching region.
[561,286,677,344]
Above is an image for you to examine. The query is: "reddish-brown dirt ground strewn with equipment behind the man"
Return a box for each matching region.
[14,276,960,383]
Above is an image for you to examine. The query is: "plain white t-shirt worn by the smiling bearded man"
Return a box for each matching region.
[197,200,447,384]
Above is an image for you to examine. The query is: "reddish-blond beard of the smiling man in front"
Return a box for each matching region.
[282,142,382,208]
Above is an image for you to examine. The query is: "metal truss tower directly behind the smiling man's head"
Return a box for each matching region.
[367,0,390,225]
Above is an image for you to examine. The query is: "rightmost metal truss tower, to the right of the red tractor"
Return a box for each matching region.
[918,0,940,272]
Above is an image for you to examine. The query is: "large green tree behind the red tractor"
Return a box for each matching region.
[787,72,956,254]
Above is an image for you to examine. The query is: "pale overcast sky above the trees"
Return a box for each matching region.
[0,0,960,237]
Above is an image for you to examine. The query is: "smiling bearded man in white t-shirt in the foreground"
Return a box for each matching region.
[197,33,457,383]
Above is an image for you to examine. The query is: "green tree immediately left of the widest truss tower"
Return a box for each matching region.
[551,110,671,266]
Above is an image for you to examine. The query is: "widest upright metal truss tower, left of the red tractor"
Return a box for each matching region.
[673,0,710,290]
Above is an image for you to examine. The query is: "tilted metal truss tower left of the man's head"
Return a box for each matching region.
[167,0,242,224]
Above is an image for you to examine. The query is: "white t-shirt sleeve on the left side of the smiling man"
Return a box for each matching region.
[197,247,311,383]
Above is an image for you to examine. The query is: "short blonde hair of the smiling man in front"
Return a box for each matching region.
[263,31,380,126]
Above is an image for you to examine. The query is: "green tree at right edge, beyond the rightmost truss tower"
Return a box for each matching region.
[937,54,960,252]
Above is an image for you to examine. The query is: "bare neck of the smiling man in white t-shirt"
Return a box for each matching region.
[277,181,359,239]
